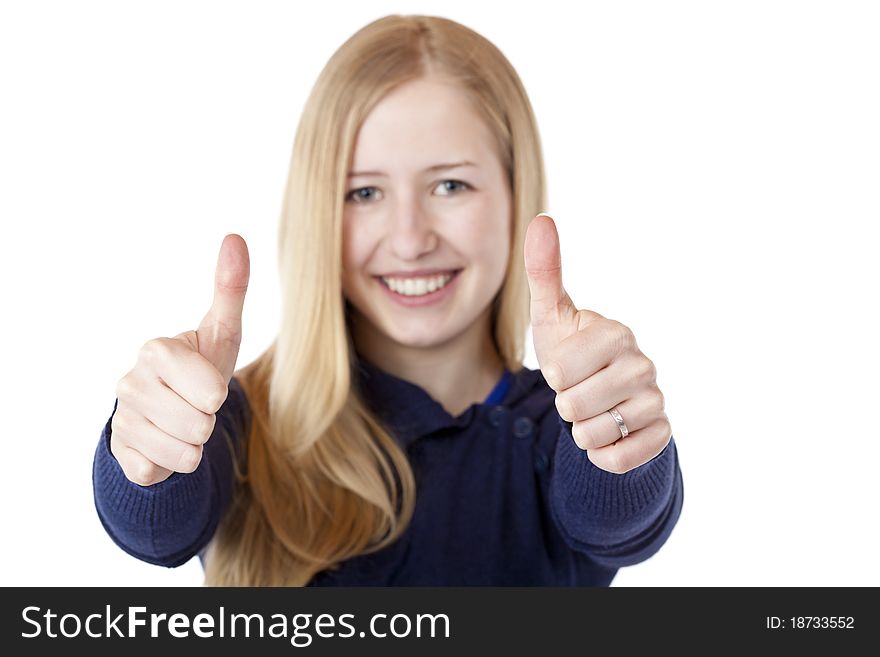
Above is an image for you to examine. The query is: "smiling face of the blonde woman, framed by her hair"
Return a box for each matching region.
[343,78,512,353]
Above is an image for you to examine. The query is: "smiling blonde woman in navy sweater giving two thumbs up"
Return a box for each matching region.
[94,16,683,586]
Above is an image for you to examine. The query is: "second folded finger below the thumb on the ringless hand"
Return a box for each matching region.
[117,377,217,445]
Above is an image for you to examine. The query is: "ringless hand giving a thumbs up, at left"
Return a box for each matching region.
[110,233,250,486]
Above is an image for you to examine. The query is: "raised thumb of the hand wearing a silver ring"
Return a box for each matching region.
[523,213,577,364]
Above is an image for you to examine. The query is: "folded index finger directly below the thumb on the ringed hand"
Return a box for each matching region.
[541,317,622,392]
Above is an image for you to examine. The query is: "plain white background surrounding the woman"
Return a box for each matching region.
[0,0,880,586]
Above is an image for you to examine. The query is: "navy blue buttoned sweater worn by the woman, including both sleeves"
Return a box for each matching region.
[92,360,684,586]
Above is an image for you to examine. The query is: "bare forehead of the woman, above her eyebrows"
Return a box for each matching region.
[352,79,495,173]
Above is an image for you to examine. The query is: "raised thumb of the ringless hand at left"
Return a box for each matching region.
[196,233,250,385]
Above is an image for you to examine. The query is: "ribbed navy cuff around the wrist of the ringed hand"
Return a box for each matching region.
[550,417,680,547]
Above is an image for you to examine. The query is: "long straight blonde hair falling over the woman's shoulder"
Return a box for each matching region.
[204,15,546,586]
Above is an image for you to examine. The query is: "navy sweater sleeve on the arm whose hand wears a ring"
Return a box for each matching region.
[550,417,684,568]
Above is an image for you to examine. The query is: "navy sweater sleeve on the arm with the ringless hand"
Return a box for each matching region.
[92,377,249,568]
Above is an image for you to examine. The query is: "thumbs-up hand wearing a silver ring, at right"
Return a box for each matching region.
[523,213,672,474]
